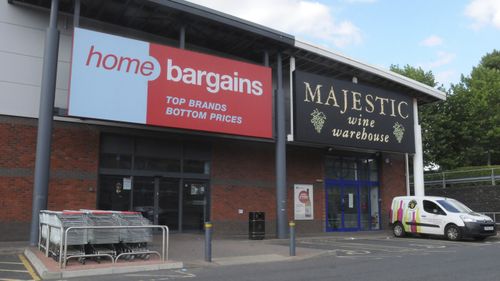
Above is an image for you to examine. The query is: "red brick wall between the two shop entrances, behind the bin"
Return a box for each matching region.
[211,141,325,237]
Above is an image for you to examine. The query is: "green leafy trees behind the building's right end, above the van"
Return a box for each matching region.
[391,50,500,169]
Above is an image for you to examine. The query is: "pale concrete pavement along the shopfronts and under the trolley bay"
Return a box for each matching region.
[0,230,500,278]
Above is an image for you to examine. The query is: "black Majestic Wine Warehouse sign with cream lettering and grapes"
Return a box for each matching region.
[294,71,415,153]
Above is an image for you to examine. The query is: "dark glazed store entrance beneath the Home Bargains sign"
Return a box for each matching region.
[97,135,211,232]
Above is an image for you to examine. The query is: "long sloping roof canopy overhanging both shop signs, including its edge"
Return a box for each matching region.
[8,0,446,104]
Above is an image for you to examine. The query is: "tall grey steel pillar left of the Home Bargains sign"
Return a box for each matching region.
[30,0,59,246]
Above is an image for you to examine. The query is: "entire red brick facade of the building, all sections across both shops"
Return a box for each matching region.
[0,117,406,240]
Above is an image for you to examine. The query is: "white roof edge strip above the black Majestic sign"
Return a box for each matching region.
[295,40,446,100]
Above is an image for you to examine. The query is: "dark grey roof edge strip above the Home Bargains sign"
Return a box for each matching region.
[149,0,295,46]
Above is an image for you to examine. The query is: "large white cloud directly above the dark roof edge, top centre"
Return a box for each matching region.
[191,0,362,48]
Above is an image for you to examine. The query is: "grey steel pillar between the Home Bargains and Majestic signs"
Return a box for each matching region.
[276,53,288,236]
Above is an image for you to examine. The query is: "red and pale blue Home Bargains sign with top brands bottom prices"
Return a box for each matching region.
[68,28,272,138]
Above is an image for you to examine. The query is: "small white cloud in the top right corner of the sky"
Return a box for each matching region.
[465,0,500,29]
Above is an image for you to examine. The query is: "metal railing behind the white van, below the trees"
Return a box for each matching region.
[424,167,500,188]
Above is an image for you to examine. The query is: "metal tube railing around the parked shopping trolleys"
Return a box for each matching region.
[38,223,169,269]
